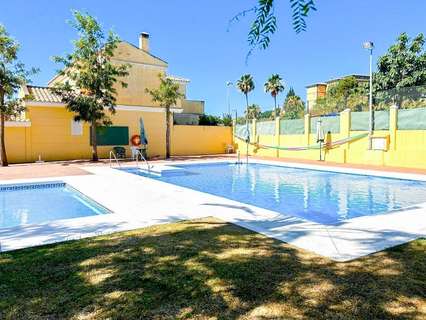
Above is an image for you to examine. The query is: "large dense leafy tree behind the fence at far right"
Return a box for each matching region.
[373,33,426,106]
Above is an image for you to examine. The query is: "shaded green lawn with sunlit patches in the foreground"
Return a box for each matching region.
[0,219,426,319]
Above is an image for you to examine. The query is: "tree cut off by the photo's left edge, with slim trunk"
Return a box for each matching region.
[0,25,37,167]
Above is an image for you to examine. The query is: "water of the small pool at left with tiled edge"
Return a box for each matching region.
[0,182,109,228]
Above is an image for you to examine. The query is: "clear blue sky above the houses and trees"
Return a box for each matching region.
[0,0,426,115]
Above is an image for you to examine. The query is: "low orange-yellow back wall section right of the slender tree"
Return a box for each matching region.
[171,126,232,156]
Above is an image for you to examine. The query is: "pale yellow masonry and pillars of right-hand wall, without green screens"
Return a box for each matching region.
[235,110,426,169]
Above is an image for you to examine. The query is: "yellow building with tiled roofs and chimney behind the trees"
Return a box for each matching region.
[6,33,223,162]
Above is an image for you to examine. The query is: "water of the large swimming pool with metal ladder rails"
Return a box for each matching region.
[121,163,426,224]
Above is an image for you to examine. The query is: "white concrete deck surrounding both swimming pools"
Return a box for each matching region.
[0,160,426,261]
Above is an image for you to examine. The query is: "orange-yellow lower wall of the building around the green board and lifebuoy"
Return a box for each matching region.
[6,107,166,163]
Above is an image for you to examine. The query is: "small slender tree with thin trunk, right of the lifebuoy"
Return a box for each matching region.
[145,74,183,159]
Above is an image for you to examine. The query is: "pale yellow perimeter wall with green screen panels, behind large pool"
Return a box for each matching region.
[234,107,426,169]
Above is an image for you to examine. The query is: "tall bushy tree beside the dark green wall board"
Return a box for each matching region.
[54,11,129,161]
